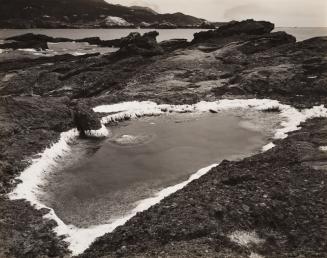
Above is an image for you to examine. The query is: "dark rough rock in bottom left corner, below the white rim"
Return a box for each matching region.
[0,196,70,258]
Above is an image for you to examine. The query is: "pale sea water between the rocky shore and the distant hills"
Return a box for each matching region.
[0,27,327,58]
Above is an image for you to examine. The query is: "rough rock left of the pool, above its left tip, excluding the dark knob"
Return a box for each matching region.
[0,97,74,190]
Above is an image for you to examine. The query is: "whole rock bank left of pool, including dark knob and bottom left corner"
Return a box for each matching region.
[0,97,101,258]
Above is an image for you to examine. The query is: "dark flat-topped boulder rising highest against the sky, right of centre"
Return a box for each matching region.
[193,19,275,43]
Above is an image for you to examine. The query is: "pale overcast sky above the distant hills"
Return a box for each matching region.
[106,0,327,27]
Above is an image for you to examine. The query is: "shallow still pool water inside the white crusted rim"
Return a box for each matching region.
[39,112,278,227]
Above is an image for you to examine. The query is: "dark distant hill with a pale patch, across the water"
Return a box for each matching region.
[0,0,211,28]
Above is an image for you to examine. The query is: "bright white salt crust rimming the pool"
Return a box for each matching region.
[8,99,327,255]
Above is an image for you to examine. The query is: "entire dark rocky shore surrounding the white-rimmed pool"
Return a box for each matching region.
[0,20,327,257]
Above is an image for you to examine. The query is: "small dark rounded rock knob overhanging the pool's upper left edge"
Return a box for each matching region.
[72,102,101,137]
